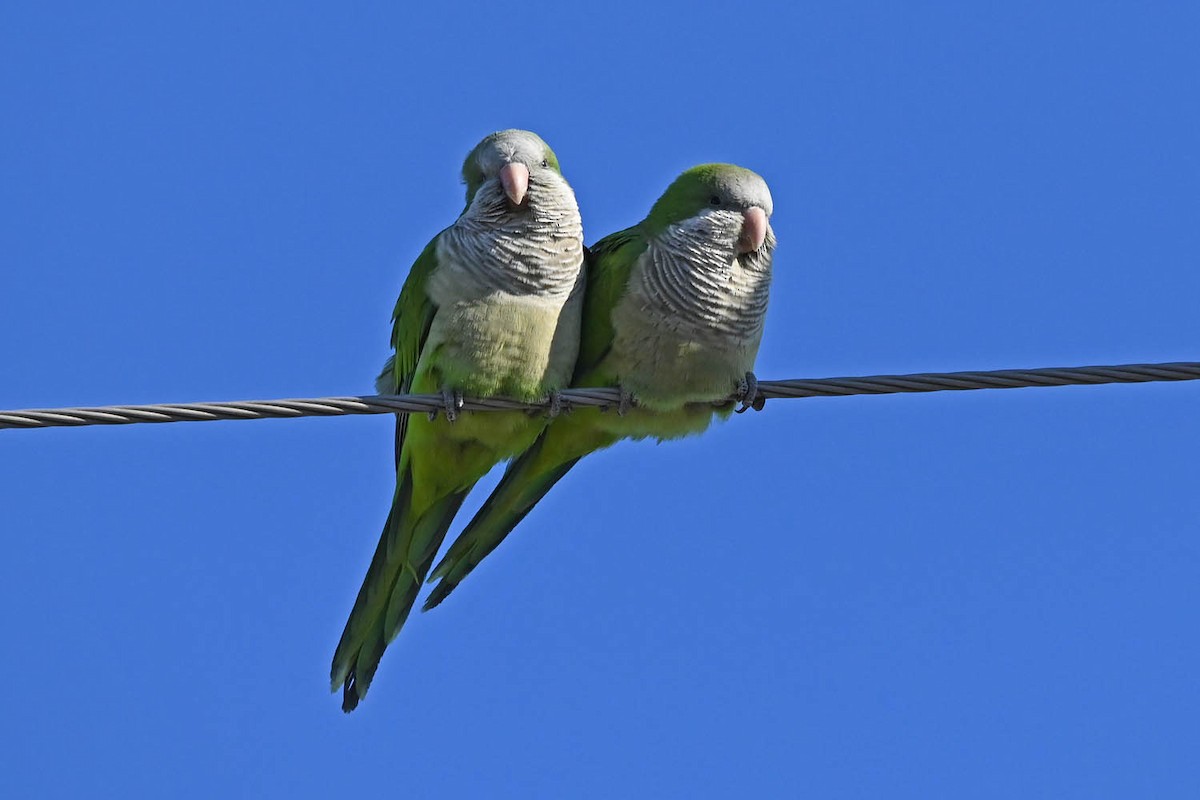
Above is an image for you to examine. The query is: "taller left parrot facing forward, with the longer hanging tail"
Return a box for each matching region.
[330,130,586,711]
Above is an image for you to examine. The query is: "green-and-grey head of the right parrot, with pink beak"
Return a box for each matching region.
[642,164,775,255]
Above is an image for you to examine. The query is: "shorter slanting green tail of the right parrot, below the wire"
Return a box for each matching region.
[424,434,582,610]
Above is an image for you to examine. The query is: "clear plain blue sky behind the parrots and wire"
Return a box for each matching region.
[0,2,1200,798]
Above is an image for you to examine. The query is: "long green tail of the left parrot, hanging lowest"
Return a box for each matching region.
[330,468,470,711]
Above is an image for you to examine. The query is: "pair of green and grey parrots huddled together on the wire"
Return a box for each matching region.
[331,130,775,711]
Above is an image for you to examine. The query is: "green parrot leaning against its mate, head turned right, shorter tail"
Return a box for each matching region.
[425,164,775,610]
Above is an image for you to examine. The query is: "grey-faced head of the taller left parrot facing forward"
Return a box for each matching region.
[462,128,565,206]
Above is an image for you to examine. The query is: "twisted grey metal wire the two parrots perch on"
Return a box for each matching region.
[0,361,1200,428]
